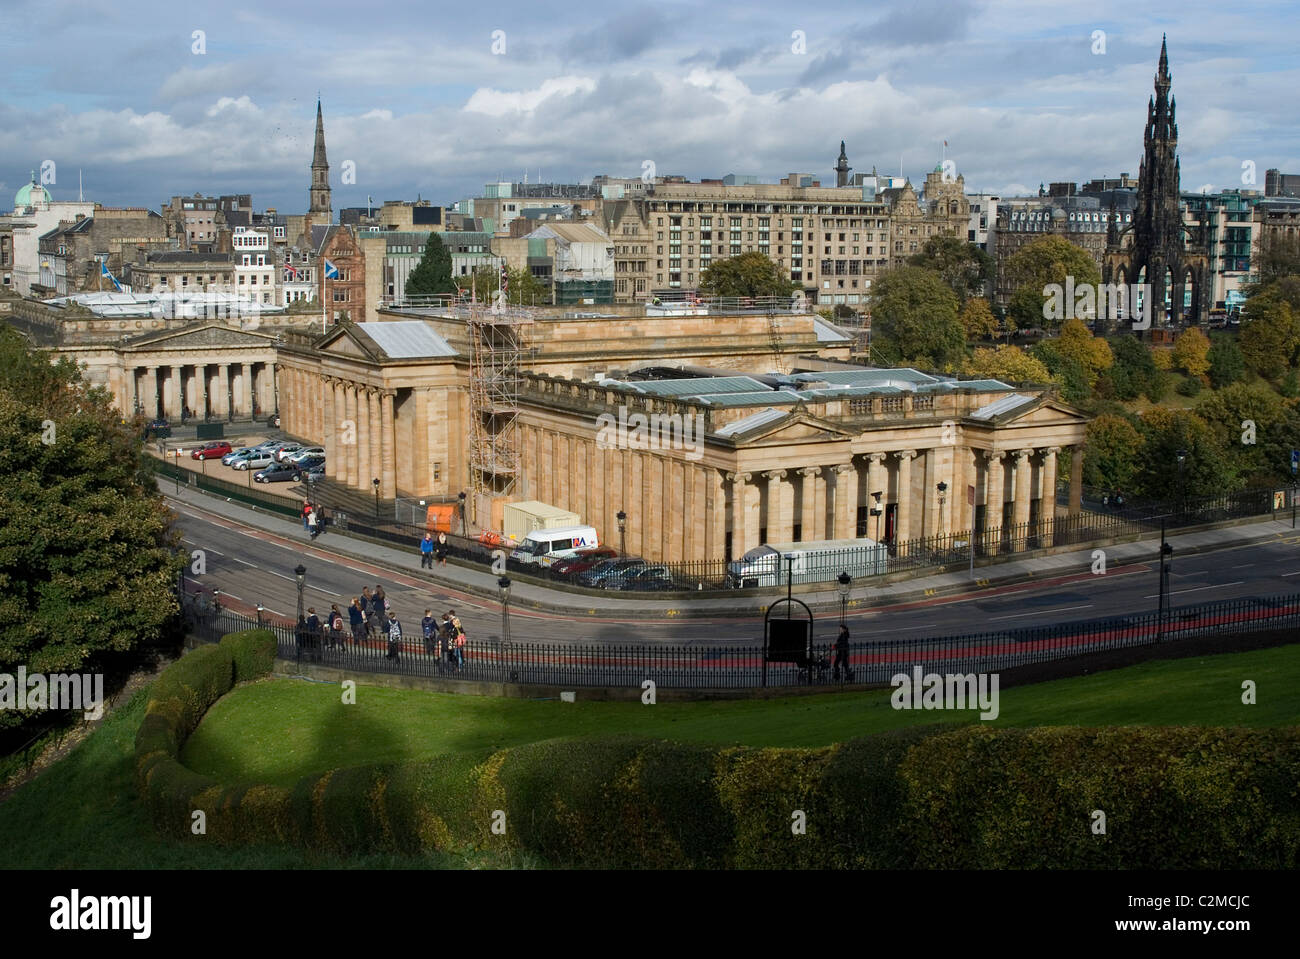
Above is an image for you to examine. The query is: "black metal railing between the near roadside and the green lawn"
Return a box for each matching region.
[182,574,1300,689]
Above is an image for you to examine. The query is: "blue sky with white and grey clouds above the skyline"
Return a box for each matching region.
[0,0,1300,212]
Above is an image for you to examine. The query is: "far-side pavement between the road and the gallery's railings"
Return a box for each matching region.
[159,478,1300,620]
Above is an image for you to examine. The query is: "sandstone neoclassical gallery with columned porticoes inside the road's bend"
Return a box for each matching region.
[278,311,1086,561]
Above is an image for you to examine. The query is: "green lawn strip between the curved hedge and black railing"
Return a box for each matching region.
[183,646,1300,785]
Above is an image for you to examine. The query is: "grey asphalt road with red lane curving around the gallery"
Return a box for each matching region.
[172,493,1300,645]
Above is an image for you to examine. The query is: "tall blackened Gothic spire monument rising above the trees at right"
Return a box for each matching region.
[1104,39,1210,340]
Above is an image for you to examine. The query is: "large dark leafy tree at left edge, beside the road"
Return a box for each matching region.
[0,326,182,732]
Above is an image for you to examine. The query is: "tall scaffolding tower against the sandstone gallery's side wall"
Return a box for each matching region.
[467,303,533,515]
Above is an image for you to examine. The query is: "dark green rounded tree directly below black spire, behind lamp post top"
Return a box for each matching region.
[1135,407,1242,502]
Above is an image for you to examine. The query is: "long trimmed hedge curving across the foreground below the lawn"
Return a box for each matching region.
[137,647,1300,869]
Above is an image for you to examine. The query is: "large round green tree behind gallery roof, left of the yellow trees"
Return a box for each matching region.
[871,266,966,369]
